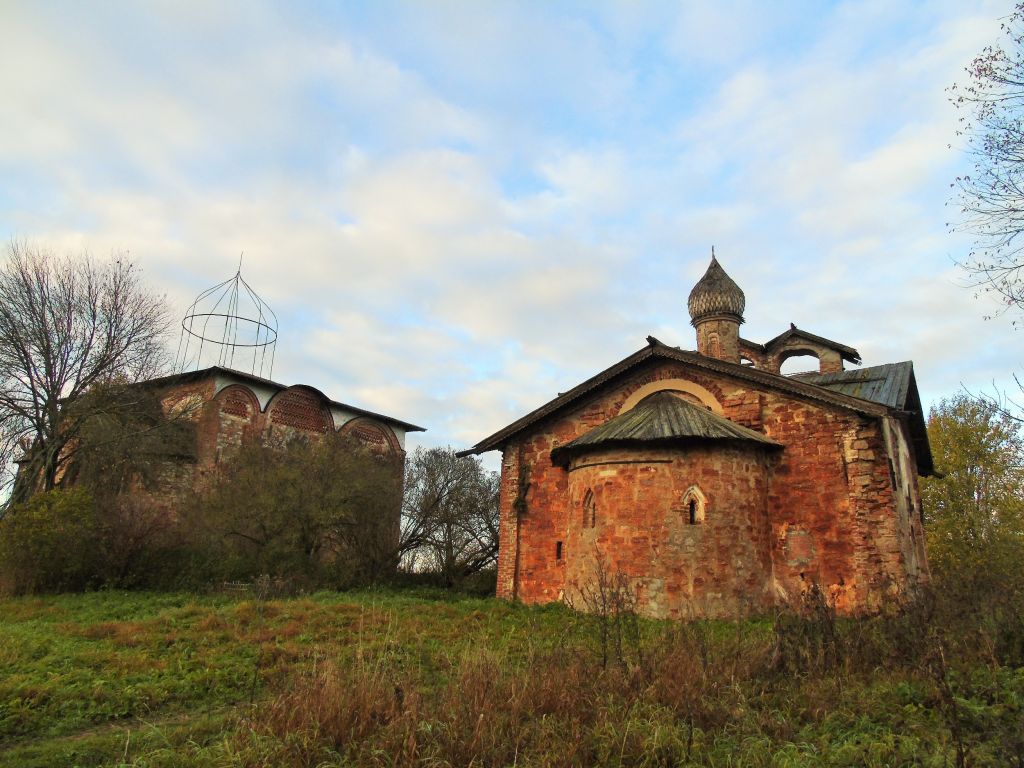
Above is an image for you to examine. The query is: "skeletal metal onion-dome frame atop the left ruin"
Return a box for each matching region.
[174,263,278,379]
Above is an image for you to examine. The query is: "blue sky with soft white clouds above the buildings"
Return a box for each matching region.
[0,0,1024,460]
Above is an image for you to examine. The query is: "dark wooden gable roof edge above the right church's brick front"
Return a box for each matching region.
[459,336,889,456]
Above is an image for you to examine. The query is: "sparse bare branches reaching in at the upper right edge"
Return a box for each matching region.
[949,3,1024,309]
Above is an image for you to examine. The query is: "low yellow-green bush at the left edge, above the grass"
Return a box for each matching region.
[0,489,101,594]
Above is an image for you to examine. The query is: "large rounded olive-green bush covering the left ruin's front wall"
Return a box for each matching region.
[185,433,401,587]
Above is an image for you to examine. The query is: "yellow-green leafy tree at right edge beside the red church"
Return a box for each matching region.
[922,394,1024,578]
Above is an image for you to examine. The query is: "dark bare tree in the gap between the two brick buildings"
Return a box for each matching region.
[400,447,499,585]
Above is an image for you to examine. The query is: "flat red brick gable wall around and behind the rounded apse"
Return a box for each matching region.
[498,361,929,612]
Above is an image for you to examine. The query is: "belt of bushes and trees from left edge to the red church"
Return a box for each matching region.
[0,434,498,594]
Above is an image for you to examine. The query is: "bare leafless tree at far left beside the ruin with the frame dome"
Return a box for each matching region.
[0,242,168,501]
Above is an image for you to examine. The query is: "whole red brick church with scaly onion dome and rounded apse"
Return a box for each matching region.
[465,256,933,617]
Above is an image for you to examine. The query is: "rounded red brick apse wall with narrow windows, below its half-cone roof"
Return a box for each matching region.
[565,445,773,618]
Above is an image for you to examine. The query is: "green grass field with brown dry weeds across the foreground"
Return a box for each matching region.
[0,592,1024,767]
